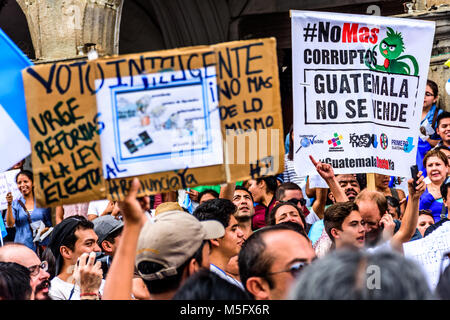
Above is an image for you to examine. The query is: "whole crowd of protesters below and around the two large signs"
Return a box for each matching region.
[0,4,450,301]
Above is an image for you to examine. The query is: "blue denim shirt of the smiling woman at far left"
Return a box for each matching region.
[7,197,52,251]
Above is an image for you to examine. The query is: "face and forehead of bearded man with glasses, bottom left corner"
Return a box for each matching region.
[11,248,50,300]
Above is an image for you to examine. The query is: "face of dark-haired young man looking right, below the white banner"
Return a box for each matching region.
[334,211,365,248]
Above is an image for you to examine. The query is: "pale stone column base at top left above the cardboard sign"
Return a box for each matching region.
[17,0,124,63]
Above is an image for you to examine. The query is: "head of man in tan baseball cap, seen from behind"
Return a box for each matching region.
[135,210,225,300]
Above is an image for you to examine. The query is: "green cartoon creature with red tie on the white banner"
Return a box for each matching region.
[366,27,419,76]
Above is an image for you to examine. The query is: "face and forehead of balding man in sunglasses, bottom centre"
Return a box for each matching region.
[264,230,316,300]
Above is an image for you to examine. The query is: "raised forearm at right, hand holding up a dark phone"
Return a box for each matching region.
[391,171,426,252]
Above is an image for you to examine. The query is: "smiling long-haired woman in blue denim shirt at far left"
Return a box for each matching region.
[6,170,52,255]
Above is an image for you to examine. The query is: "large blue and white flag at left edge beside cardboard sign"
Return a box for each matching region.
[0,29,33,172]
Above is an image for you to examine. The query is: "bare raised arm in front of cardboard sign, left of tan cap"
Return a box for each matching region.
[103,178,146,300]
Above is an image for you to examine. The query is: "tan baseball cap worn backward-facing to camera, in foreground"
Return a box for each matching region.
[135,210,225,280]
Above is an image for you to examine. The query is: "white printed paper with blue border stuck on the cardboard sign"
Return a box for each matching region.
[97,67,223,178]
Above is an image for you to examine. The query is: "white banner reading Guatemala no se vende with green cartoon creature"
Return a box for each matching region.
[291,11,435,177]
